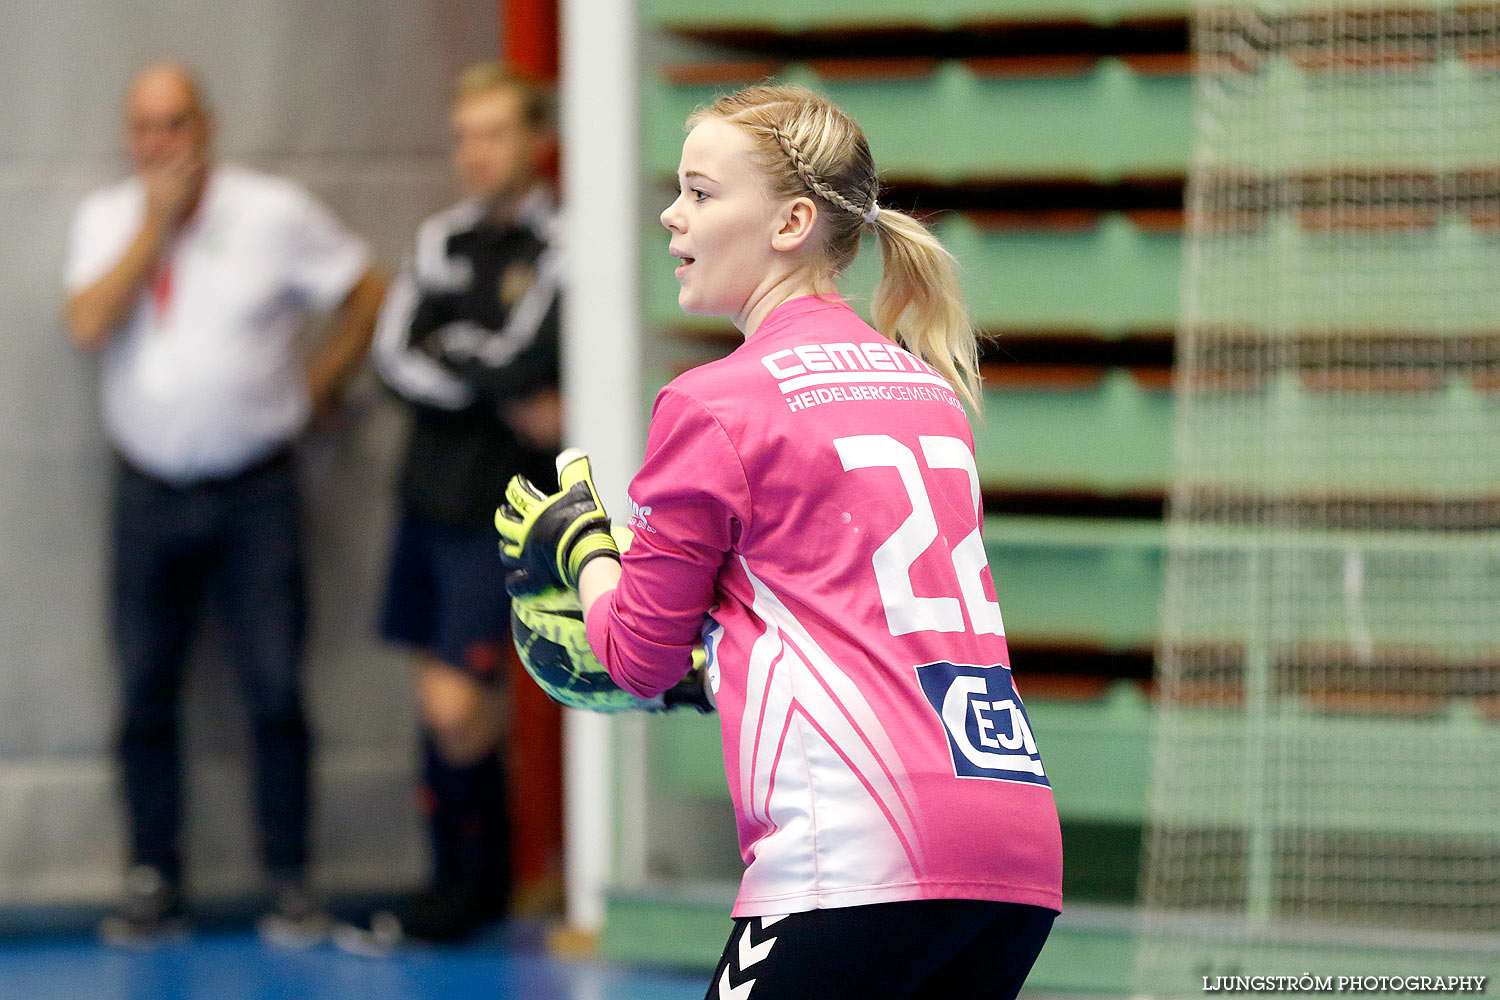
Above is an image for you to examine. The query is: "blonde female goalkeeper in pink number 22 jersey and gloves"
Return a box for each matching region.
[501,87,1062,1000]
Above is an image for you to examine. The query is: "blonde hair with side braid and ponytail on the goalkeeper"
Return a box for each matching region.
[687,85,983,418]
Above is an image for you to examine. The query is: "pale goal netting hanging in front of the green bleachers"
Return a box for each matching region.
[1136,3,1500,996]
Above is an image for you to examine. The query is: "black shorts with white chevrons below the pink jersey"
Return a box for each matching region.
[705,900,1058,1000]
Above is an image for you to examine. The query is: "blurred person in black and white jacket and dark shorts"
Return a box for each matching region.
[344,64,561,949]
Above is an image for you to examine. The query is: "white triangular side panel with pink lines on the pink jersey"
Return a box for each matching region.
[740,556,923,891]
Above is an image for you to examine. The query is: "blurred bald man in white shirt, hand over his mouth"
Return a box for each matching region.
[66,64,384,943]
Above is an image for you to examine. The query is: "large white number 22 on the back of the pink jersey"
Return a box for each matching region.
[834,435,1005,636]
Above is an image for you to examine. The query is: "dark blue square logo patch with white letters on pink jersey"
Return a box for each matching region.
[917,661,1052,787]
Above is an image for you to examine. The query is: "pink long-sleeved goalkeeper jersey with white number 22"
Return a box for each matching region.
[588,297,1062,916]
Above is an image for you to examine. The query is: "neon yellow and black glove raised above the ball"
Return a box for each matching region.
[495,448,620,591]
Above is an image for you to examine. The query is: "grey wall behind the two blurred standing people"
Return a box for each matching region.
[0,0,498,906]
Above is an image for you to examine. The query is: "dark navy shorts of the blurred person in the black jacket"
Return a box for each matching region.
[381,517,510,682]
